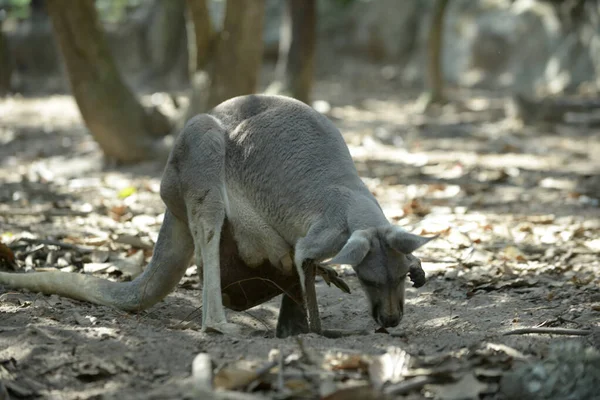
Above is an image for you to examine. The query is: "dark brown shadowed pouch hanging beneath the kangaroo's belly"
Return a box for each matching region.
[219,219,301,311]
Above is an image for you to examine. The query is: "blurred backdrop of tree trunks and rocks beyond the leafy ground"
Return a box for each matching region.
[0,0,600,162]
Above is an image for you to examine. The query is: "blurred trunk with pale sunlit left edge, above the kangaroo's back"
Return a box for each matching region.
[268,0,317,103]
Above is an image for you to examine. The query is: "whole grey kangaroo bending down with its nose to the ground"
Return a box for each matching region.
[0,95,435,337]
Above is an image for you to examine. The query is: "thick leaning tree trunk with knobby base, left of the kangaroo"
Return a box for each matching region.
[46,0,170,163]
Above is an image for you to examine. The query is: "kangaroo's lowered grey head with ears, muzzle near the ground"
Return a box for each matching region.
[326,226,435,327]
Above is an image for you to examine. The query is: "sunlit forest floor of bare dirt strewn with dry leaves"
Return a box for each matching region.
[0,60,600,400]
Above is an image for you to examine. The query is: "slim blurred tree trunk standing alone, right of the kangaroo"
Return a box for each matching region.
[427,0,448,103]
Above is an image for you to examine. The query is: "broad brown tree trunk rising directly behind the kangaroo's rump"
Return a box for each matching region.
[208,0,265,107]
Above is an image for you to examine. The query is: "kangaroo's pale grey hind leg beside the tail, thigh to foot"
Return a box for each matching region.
[176,115,240,335]
